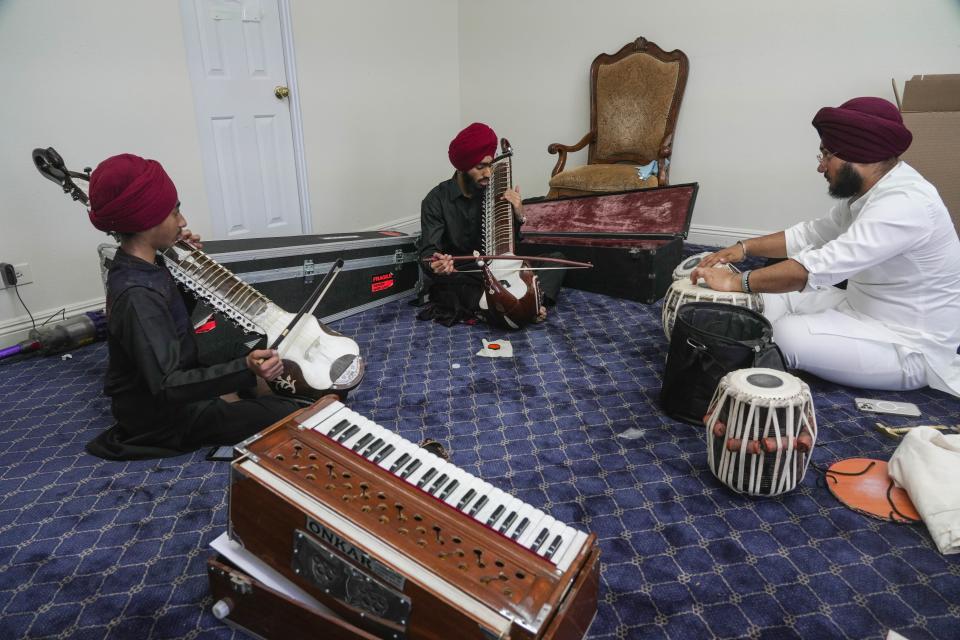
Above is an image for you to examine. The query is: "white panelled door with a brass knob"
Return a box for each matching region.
[180,0,310,239]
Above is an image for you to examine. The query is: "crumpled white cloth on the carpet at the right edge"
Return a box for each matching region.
[887,427,960,554]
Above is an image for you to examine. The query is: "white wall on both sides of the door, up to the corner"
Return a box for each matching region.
[0,0,459,346]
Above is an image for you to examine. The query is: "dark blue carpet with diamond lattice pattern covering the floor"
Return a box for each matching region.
[0,260,960,640]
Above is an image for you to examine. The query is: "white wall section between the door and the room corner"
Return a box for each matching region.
[291,0,460,233]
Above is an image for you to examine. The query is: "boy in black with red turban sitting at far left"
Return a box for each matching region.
[87,154,299,460]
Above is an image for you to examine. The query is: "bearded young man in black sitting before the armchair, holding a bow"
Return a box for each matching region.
[418,122,564,326]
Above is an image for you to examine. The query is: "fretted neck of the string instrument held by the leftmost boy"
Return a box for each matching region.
[161,240,272,333]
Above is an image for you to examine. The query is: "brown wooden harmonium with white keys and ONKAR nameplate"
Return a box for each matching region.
[225,396,599,640]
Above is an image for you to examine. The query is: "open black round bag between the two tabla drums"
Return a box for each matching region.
[660,302,786,425]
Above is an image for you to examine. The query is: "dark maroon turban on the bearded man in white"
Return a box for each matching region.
[813,98,913,163]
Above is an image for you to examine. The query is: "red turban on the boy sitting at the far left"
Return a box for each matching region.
[90,153,177,233]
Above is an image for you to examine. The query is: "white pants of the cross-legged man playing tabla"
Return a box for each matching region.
[763,287,927,391]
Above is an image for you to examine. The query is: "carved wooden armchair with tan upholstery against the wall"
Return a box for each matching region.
[547,38,690,198]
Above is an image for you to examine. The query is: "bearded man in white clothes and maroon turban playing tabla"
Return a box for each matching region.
[691,98,960,396]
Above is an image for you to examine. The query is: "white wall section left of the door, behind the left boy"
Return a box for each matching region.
[0,0,209,344]
